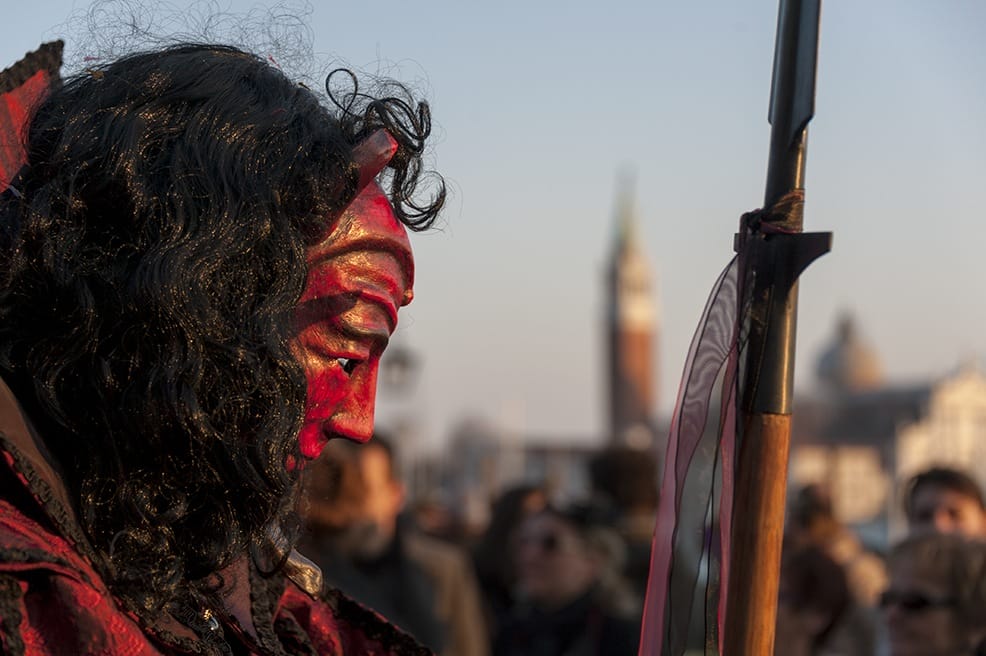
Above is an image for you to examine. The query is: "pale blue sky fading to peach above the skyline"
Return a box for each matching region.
[0,0,986,452]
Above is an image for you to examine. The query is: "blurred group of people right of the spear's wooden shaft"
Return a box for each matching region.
[774,467,986,656]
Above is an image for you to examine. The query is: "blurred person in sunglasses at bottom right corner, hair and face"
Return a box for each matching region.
[880,532,986,656]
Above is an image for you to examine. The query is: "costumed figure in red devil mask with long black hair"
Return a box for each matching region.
[0,44,444,654]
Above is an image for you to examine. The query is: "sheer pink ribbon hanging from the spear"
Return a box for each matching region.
[639,257,743,656]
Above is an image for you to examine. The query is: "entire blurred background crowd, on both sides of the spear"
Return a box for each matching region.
[300,435,986,656]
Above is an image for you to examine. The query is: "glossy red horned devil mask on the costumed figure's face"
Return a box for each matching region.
[292,182,414,459]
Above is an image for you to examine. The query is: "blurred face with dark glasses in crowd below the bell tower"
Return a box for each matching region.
[516,513,600,610]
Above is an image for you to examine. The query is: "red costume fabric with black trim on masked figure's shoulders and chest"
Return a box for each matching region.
[0,381,431,656]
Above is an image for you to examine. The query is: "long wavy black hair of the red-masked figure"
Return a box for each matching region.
[0,44,445,617]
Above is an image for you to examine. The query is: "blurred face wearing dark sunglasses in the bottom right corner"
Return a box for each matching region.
[880,560,973,656]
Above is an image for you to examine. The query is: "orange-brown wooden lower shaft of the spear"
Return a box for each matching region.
[722,414,791,656]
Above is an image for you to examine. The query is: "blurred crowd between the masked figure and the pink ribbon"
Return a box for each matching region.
[299,435,658,656]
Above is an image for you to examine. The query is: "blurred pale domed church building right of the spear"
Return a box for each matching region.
[789,316,986,549]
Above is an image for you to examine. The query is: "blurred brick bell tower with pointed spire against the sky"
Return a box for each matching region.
[606,179,658,449]
